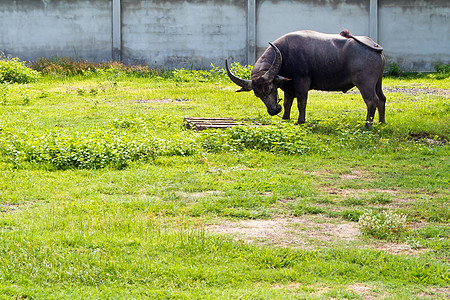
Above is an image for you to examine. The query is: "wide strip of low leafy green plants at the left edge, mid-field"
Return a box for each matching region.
[0,130,195,170]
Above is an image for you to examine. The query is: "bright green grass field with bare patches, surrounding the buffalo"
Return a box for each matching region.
[0,62,450,299]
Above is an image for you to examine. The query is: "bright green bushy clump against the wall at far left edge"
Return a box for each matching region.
[0,53,40,83]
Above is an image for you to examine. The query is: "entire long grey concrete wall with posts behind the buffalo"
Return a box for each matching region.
[0,0,450,71]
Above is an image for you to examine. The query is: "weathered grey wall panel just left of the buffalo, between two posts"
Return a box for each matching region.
[122,0,247,68]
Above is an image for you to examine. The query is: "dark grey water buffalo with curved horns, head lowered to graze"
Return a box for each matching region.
[225,30,386,127]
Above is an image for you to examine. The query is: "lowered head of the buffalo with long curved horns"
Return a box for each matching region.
[225,43,290,116]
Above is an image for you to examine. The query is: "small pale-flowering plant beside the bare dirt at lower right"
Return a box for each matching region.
[359,211,408,240]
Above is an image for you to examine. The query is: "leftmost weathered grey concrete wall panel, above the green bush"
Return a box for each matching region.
[0,0,112,61]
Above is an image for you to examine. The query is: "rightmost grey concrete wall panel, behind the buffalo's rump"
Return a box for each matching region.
[379,0,450,71]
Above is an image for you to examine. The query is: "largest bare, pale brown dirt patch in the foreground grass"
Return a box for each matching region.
[205,216,429,255]
